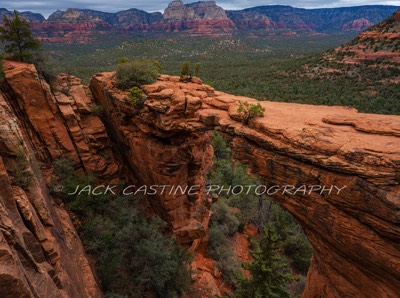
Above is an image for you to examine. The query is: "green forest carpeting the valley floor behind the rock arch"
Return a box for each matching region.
[45,34,400,114]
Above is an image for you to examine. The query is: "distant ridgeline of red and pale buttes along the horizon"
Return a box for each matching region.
[0,1,398,43]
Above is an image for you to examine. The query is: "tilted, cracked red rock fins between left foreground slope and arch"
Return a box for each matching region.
[3,61,119,180]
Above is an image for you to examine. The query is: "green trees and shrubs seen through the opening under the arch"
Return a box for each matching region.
[208,132,312,297]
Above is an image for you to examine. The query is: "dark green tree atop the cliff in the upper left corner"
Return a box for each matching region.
[0,10,40,62]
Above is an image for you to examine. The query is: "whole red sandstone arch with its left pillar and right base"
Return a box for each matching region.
[90,73,400,297]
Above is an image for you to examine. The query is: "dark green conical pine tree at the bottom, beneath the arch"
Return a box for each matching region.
[236,226,292,298]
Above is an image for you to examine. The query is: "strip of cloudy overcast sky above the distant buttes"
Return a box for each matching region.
[0,0,400,17]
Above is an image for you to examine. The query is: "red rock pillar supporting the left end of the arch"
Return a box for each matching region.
[90,73,213,245]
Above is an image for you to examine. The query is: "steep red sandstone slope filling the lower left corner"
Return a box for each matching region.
[0,91,102,298]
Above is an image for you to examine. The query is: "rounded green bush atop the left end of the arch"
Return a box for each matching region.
[116,60,161,89]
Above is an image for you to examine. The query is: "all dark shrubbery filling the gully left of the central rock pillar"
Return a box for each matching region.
[53,158,191,298]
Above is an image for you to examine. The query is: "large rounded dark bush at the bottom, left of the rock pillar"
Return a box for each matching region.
[83,197,190,297]
